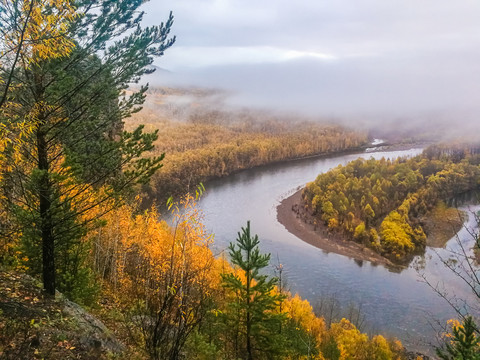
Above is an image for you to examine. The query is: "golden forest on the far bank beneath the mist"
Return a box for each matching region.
[127,94,367,203]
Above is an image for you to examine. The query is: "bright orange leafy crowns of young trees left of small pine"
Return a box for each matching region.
[90,196,219,308]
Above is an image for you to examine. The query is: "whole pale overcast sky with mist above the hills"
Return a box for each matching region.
[144,0,480,130]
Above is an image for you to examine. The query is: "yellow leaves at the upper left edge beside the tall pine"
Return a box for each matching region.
[0,0,78,246]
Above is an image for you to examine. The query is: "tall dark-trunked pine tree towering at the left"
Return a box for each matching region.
[0,0,175,295]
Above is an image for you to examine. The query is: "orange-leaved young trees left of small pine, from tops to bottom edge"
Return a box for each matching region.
[89,196,219,359]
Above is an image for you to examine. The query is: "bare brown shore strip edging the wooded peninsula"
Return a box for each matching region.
[277,189,405,271]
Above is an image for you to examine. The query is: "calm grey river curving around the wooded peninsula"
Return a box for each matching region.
[199,149,478,353]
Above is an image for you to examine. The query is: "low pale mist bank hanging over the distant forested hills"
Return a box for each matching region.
[146,60,480,140]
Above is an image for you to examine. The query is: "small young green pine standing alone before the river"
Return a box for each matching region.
[222,222,286,360]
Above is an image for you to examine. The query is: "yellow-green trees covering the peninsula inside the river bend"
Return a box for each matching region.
[303,145,480,261]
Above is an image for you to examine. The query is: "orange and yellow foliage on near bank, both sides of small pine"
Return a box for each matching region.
[76,195,402,360]
